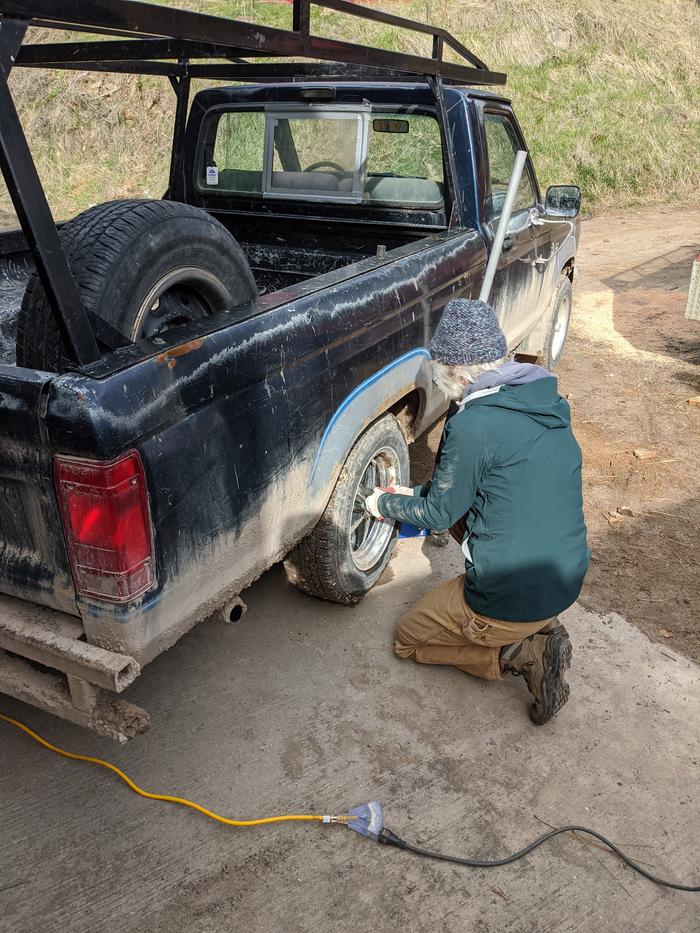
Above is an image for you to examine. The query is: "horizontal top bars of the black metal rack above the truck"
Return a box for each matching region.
[0,0,506,85]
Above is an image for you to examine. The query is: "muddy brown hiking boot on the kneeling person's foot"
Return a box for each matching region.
[501,624,571,726]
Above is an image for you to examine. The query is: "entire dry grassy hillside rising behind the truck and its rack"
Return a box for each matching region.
[0,0,700,225]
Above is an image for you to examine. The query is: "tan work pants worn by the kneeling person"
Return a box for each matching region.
[394,574,552,680]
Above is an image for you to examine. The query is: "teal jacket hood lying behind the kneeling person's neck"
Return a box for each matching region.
[460,364,571,428]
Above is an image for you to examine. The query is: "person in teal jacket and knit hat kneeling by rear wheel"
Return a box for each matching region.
[367,300,590,724]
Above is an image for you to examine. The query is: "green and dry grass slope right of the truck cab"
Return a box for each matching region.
[323,0,700,208]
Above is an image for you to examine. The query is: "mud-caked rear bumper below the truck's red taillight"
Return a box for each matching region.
[0,595,149,742]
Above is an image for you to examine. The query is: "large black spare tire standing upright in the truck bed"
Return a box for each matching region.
[17,200,258,372]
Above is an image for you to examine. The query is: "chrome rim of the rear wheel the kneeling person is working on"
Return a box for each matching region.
[348,447,401,571]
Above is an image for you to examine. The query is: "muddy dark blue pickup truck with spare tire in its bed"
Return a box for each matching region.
[0,3,579,739]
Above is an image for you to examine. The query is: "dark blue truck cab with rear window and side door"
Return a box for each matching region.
[179,83,577,352]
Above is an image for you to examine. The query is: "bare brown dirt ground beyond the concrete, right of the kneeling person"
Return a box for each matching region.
[412,207,700,661]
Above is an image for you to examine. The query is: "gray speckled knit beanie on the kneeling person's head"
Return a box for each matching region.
[430,298,508,366]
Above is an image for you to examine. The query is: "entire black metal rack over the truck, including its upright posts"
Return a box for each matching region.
[0,0,506,365]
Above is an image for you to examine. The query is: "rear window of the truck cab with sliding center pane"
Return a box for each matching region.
[196,105,444,211]
